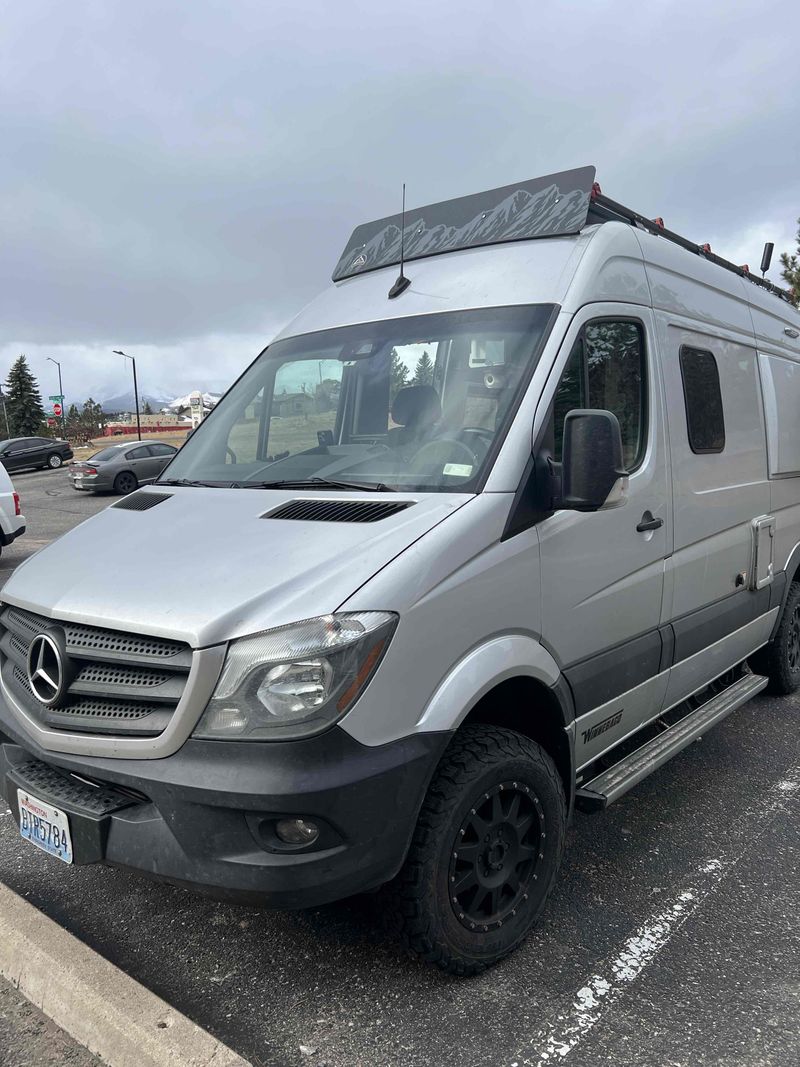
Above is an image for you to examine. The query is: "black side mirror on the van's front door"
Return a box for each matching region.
[561,409,627,511]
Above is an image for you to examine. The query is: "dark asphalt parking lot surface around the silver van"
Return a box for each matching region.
[0,472,800,1067]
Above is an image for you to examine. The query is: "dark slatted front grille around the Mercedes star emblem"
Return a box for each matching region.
[0,607,192,737]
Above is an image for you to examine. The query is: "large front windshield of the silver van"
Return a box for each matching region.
[162,304,553,492]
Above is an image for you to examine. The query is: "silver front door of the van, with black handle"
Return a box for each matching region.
[539,304,672,766]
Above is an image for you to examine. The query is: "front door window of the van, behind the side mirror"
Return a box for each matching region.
[554,319,647,471]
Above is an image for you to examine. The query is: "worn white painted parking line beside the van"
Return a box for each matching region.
[511,764,800,1067]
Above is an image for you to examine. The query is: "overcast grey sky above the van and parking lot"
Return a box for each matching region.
[0,0,800,397]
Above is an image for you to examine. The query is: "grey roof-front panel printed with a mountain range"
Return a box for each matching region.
[333,166,594,282]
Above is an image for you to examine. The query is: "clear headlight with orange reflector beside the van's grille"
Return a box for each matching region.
[194,611,398,740]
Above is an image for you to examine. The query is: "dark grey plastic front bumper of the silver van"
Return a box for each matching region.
[0,723,450,908]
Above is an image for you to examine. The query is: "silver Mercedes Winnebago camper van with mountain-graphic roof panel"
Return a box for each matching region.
[0,168,800,974]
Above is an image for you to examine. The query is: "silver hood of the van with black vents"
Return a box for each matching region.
[2,487,470,648]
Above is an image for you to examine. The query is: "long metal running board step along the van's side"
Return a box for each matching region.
[575,674,768,811]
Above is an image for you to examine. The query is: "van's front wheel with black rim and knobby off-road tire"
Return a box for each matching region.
[385,724,566,976]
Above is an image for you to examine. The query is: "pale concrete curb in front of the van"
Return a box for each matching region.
[0,882,251,1067]
